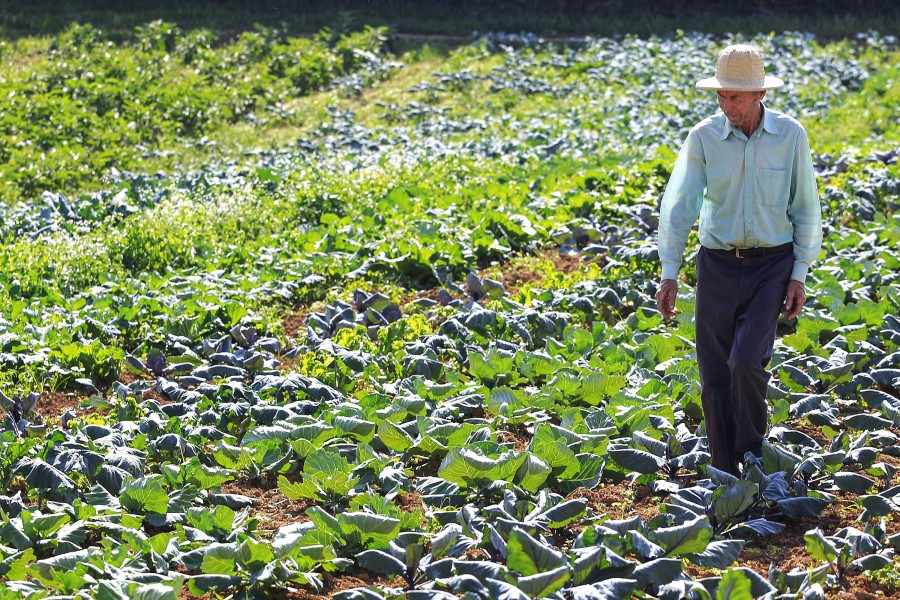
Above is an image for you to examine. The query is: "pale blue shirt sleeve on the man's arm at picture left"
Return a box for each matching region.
[658,131,706,279]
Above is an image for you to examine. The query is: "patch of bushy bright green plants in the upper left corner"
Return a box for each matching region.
[0,21,385,202]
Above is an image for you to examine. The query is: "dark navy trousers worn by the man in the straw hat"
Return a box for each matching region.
[694,247,794,475]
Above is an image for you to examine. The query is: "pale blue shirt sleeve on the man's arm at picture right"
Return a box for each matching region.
[787,131,822,282]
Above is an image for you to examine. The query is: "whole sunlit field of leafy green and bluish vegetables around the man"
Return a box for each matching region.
[0,21,900,600]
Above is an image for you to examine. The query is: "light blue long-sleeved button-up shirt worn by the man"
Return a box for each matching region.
[659,107,822,282]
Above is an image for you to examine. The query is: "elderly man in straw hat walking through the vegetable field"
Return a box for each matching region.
[656,44,822,475]
